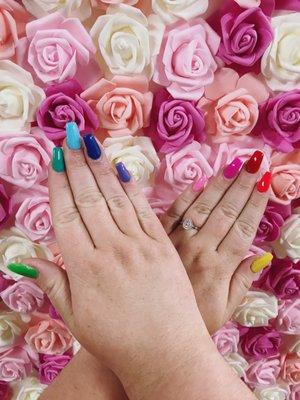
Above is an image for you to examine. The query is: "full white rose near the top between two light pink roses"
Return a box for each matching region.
[90,4,164,76]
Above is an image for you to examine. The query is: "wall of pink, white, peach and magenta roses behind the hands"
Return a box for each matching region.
[0,0,300,400]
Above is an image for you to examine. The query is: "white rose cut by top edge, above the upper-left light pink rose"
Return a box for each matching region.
[23,0,91,21]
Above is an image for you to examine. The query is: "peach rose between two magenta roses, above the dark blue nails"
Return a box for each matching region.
[81,76,153,137]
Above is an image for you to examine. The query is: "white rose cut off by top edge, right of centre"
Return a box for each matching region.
[152,0,208,24]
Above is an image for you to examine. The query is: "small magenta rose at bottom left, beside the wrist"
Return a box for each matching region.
[39,354,71,385]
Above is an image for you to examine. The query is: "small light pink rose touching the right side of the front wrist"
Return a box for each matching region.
[212,321,240,356]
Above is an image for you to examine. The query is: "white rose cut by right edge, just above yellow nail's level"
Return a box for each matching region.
[272,214,300,262]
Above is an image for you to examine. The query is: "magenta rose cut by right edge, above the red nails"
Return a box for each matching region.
[255,89,300,153]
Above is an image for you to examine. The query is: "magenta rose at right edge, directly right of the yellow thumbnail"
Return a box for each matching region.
[254,258,300,300]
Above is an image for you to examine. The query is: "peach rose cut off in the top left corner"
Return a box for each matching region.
[0,0,29,60]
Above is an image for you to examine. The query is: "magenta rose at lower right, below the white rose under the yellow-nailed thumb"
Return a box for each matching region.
[240,327,281,360]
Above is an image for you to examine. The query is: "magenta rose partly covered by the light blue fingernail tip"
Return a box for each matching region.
[36,79,99,144]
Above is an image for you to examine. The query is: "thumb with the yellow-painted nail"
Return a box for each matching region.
[228,253,273,316]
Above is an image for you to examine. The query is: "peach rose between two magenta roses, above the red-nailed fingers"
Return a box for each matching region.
[198,68,269,143]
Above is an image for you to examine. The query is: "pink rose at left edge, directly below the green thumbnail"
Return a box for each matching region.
[0,279,44,314]
